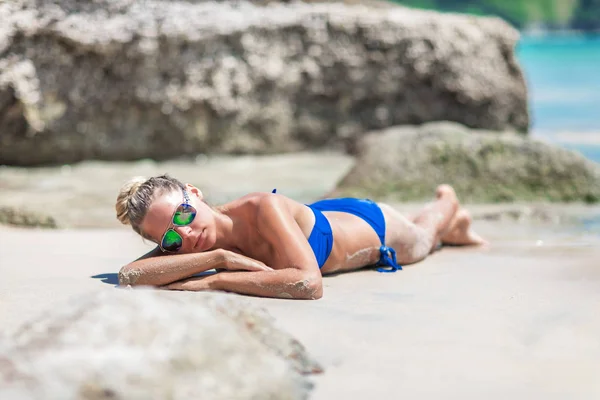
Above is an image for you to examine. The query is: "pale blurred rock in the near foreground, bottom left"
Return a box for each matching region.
[0,290,319,399]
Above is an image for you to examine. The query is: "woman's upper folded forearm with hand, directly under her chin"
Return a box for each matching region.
[119,248,271,286]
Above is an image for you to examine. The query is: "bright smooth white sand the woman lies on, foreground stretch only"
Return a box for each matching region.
[0,222,600,400]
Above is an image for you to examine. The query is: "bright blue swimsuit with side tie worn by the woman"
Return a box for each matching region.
[307,198,402,272]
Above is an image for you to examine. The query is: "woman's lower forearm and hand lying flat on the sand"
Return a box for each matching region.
[166,268,323,300]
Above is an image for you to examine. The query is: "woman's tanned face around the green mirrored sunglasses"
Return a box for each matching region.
[140,185,216,254]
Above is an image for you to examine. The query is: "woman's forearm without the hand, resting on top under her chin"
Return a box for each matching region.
[119,250,225,286]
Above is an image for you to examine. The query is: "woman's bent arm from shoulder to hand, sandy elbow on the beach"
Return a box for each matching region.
[165,196,323,299]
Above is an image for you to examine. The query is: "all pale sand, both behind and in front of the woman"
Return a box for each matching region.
[0,154,600,400]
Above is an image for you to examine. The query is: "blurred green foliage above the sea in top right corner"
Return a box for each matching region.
[392,0,600,30]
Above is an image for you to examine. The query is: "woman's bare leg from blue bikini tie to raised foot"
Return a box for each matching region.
[379,185,459,264]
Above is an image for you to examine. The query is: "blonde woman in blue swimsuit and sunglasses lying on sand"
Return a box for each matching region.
[116,176,484,299]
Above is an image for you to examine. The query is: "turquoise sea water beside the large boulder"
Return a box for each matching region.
[517,34,600,162]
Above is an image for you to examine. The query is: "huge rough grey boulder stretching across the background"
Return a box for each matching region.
[0,0,529,165]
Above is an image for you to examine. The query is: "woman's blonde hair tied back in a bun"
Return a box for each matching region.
[115,175,185,237]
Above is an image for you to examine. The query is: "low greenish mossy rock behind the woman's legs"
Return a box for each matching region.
[333,123,600,203]
